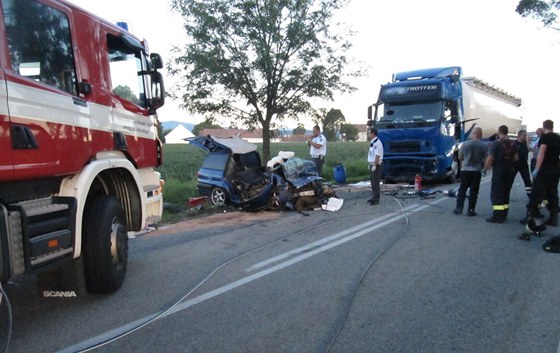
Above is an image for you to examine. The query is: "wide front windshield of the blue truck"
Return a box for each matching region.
[376,101,443,129]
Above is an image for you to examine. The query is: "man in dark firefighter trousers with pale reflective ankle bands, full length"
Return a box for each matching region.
[482,125,519,223]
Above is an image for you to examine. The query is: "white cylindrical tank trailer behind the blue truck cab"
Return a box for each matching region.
[462,77,523,139]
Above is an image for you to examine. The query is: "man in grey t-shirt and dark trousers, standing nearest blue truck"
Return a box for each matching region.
[453,127,488,217]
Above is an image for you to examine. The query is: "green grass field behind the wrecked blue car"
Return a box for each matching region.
[157,142,369,222]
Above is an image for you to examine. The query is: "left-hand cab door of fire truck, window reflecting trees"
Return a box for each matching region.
[2,0,92,179]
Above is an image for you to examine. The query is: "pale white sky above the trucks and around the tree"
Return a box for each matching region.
[66,0,560,131]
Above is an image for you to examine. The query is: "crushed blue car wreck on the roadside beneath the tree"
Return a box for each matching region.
[187,136,334,211]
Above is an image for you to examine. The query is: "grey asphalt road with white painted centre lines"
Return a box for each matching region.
[0,174,560,353]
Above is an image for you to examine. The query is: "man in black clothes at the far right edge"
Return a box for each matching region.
[521,120,560,227]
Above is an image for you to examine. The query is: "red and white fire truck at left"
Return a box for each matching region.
[0,0,164,293]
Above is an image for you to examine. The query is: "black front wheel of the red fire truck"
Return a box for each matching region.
[82,195,128,293]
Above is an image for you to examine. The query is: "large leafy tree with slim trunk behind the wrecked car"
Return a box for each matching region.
[168,0,363,160]
